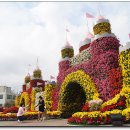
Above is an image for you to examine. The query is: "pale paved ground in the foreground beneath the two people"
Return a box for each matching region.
[0,119,130,127]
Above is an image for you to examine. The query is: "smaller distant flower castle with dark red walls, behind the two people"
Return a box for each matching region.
[15,66,46,110]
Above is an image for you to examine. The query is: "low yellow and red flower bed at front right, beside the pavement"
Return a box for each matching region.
[68,109,130,125]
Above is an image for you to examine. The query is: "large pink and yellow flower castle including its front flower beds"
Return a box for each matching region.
[15,13,130,123]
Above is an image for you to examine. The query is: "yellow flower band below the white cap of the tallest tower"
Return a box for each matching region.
[93,22,111,35]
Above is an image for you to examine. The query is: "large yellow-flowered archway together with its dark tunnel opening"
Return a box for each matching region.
[58,70,99,117]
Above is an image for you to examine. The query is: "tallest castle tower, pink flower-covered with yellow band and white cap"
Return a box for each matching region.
[90,17,122,101]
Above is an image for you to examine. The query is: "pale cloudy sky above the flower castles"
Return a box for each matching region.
[0,2,130,92]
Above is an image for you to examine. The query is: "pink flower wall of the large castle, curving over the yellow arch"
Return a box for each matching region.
[57,37,122,101]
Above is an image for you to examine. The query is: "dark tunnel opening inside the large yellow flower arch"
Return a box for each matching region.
[62,82,86,118]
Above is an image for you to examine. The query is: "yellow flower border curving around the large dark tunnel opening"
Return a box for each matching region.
[59,70,99,111]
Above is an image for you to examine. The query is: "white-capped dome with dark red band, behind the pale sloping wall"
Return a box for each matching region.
[79,32,94,52]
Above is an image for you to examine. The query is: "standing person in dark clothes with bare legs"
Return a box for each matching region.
[36,96,45,121]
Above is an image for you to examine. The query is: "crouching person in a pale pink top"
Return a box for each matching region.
[17,103,26,122]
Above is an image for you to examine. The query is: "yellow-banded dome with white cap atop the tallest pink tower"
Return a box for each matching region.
[93,15,111,35]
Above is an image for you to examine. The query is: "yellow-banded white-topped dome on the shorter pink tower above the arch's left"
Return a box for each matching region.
[61,41,74,58]
